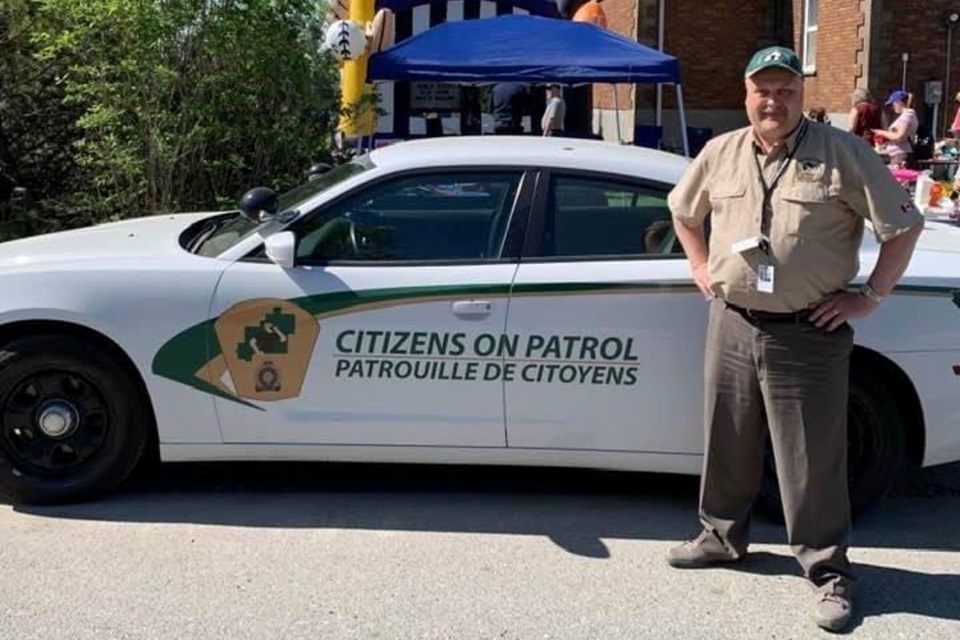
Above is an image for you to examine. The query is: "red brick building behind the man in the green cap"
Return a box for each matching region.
[594,0,960,144]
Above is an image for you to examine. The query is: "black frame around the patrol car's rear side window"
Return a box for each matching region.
[520,168,687,263]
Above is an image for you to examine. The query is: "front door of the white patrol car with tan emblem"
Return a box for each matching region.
[207,168,532,447]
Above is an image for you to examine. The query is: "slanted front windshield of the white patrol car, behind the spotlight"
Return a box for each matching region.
[188,156,373,257]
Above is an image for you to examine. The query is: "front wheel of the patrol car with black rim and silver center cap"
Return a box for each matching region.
[0,335,150,504]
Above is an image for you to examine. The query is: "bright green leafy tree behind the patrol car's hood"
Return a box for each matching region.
[10,0,338,232]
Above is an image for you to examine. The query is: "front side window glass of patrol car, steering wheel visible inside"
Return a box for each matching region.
[297,171,522,262]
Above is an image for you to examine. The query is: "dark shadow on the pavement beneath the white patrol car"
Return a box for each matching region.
[9,463,960,557]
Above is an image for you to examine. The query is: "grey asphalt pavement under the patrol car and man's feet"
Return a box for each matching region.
[0,463,960,640]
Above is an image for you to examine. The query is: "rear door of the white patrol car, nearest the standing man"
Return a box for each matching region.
[505,171,707,454]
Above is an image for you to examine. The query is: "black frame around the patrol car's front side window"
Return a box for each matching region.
[248,164,536,268]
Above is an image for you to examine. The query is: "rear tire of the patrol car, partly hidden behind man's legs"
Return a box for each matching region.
[756,361,906,521]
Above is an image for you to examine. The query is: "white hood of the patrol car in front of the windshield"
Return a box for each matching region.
[0,211,222,266]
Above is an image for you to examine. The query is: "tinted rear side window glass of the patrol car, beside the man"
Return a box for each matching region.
[540,175,682,257]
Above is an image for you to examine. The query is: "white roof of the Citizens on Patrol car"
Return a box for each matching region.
[370,135,689,183]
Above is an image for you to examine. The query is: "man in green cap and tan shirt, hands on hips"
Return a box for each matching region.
[668,47,923,631]
